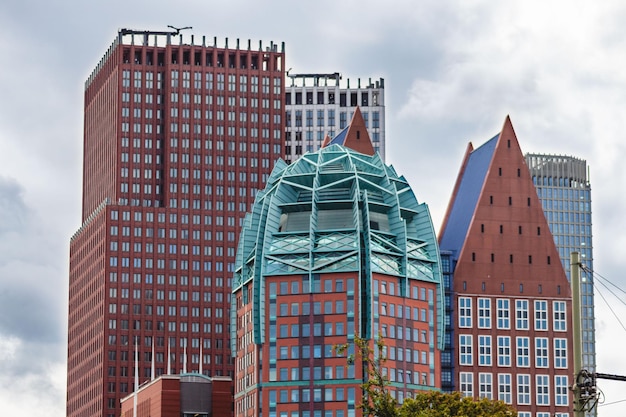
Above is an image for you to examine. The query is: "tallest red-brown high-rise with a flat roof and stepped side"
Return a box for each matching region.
[67,29,285,417]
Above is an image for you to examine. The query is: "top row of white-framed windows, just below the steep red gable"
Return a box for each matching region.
[458,297,567,332]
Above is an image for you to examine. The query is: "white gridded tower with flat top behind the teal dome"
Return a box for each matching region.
[285,72,385,163]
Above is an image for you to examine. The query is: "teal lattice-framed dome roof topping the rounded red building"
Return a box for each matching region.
[231,144,443,346]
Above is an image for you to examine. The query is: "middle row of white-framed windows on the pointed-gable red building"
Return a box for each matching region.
[459,334,567,369]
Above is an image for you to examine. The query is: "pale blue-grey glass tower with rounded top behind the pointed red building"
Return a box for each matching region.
[526,154,597,415]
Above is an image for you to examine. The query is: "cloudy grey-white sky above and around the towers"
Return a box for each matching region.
[0,0,626,417]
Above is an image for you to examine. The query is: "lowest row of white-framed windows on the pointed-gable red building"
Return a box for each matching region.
[459,372,569,406]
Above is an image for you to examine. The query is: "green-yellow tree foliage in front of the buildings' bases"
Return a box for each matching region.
[336,336,517,417]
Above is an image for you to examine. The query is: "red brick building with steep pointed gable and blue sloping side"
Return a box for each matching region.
[439,117,573,417]
